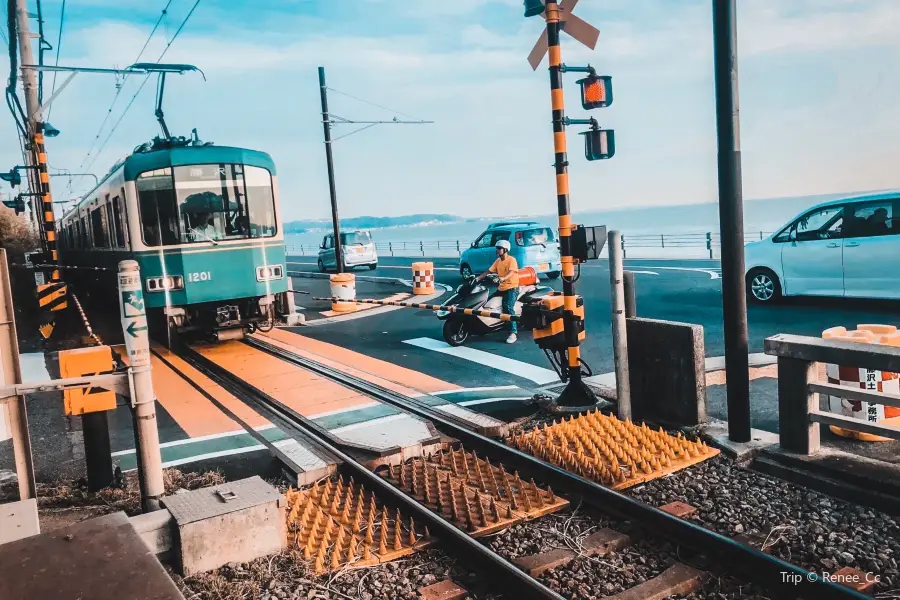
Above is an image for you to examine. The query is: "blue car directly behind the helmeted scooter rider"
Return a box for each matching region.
[459,221,562,279]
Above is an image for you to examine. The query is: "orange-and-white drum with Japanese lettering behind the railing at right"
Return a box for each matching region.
[822,324,900,442]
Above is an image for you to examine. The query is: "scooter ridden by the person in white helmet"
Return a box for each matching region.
[436,267,553,346]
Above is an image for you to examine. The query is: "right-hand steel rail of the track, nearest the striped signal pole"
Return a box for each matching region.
[245,338,867,600]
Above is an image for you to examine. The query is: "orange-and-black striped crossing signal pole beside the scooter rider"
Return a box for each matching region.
[544,0,597,406]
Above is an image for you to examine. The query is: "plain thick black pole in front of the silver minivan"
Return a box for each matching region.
[713,0,750,442]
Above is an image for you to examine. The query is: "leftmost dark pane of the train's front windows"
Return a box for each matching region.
[135,167,179,246]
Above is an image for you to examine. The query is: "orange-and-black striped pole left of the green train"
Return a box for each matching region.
[33,121,68,338]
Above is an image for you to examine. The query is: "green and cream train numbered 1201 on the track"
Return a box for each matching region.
[58,139,287,339]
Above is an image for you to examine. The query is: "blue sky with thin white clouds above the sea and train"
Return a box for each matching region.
[0,0,900,219]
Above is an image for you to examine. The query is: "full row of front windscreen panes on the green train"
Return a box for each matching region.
[138,164,276,246]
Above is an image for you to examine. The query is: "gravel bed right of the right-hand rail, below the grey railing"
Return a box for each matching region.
[628,456,900,592]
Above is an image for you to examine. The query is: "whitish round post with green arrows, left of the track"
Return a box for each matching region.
[119,260,165,512]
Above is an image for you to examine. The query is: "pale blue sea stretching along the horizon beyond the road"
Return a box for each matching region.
[285,194,864,258]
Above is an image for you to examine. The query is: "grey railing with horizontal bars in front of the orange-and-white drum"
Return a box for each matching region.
[765,334,900,454]
